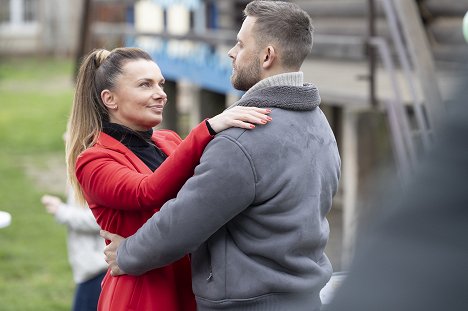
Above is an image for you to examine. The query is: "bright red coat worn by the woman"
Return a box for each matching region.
[76,122,211,311]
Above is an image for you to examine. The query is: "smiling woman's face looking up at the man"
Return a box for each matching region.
[101,59,167,131]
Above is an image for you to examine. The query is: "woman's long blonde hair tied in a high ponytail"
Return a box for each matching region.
[65,48,152,203]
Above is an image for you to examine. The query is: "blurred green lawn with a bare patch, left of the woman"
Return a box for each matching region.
[0,59,74,311]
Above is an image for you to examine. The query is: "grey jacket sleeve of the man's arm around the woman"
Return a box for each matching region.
[117,136,255,275]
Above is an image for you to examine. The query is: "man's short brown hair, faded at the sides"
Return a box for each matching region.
[244,0,314,68]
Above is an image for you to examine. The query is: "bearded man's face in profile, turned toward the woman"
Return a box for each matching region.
[228,16,261,91]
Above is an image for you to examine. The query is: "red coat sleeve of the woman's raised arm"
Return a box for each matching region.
[76,122,212,210]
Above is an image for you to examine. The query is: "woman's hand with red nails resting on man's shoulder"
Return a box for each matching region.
[208,106,272,133]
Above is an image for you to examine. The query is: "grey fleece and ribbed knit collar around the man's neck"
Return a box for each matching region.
[232,72,321,111]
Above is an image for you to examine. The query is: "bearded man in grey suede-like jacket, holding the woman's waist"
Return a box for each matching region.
[102,1,340,311]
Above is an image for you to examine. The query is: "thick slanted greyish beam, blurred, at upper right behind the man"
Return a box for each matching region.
[394,0,445,130]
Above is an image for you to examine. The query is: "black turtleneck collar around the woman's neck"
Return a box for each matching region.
[102,122,153,147]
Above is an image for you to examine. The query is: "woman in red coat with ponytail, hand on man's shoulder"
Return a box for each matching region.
[67,48,271,311]
